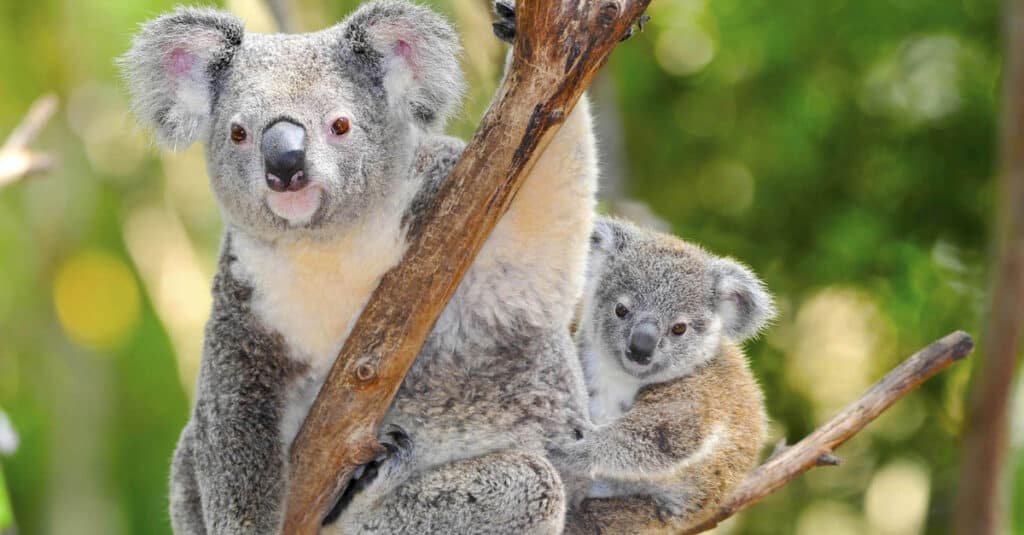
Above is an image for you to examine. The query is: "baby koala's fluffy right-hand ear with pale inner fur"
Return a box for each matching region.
[711,258,775,341]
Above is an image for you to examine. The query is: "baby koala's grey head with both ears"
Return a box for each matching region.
[580,218,775,383]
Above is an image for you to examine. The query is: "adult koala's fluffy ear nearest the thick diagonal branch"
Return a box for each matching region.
[344,0,465,130]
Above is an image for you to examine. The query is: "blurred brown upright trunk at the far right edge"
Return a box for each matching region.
[954,0,1024,535]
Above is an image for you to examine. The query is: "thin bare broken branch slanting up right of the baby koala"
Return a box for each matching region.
[683,331,974,534]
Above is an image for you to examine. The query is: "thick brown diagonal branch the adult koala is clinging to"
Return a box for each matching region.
[284,0,649,534]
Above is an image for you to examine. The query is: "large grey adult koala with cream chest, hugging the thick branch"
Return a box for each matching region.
[122,0,597,534]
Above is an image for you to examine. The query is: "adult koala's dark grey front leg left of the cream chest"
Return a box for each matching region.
[171,253,303,535]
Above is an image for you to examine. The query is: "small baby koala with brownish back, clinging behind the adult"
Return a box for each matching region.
[564,218,775,533]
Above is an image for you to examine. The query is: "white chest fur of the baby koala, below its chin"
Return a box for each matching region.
[582,347,643,425]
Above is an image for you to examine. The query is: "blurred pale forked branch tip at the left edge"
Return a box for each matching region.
[0,94,57,188]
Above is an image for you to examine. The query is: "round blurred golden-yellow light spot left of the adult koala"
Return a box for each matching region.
[53,250,139,351]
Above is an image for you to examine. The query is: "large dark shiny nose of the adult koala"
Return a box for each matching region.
[260,119,309,192]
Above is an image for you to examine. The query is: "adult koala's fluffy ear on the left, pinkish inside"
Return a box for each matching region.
[118,7,245,150]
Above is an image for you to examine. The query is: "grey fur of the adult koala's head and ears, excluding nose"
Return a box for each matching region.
[119,0,465,239]
